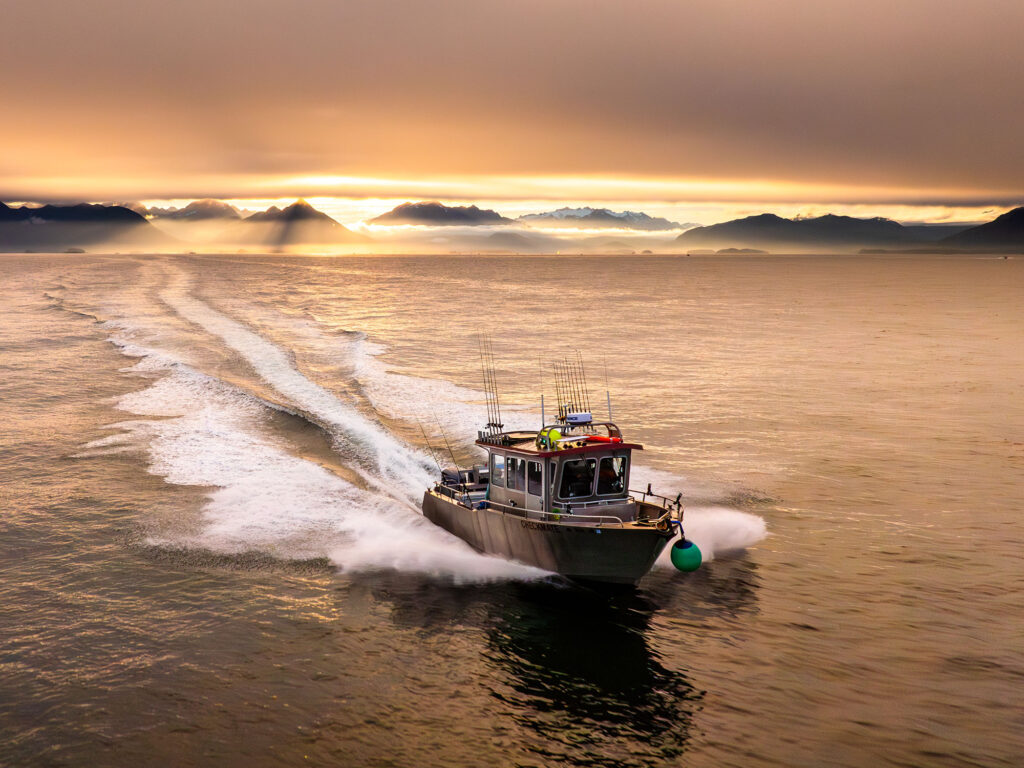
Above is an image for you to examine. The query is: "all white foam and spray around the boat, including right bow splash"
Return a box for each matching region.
[70,265,765,582]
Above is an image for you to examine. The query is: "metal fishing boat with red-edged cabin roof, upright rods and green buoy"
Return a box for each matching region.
[423,344,700,585]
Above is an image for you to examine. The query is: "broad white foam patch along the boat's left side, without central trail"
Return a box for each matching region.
[88,321,548,582]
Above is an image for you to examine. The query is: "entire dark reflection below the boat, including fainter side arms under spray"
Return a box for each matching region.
[358,573,756,766]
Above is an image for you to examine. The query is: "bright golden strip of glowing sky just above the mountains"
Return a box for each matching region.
[0,167,1024,231]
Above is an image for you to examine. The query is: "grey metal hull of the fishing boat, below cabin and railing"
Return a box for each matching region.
[423,490,674,584]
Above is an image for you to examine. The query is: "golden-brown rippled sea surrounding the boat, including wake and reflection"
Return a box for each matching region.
[0,255,1024,768]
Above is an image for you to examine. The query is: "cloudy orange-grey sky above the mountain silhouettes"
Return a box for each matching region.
[0,0,1024,223]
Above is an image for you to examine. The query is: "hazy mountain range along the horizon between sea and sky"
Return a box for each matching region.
[8,200,1024,253]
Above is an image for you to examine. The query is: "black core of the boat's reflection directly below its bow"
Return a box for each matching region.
[487,588,702,766]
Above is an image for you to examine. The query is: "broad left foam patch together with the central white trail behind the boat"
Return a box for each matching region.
[70,268,550,583]
